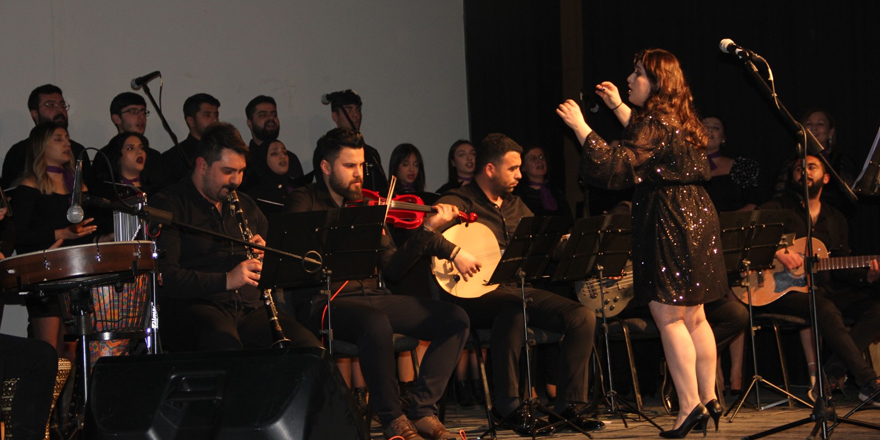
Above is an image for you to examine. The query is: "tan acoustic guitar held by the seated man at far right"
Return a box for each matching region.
[731,238,880,307]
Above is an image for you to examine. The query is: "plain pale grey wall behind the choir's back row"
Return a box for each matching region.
[0,0,468,334]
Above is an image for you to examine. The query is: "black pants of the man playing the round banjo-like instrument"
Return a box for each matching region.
[442,285,596,403]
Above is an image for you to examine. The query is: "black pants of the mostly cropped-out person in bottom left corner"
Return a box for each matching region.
[0,335,58,440]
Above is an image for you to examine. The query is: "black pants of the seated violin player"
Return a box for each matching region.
[309,294,469,426]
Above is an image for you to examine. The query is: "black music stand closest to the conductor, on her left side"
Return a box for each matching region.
[553,214,663,431]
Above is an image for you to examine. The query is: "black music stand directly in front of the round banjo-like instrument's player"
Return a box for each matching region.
[477,217,593,440]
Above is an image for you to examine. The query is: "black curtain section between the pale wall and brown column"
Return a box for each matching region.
[464,0,565,187]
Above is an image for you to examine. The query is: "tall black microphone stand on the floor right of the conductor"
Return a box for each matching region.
[737,43,880,440]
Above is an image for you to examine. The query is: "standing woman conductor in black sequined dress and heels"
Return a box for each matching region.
[557,49,726,437]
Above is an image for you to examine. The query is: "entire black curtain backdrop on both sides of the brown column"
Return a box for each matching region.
[464,0,880,253]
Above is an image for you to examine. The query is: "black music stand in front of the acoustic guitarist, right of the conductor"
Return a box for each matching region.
[719,209,812,422]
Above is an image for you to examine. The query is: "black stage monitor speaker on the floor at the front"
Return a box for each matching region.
[84,348,367,440]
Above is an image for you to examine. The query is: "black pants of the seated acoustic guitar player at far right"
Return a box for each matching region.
[759,289,880,386]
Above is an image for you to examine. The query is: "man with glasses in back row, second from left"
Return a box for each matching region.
[94,92,164,185]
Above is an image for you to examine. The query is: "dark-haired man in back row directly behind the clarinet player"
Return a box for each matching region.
[162,93,220,184]
